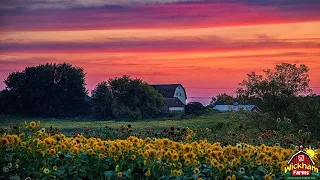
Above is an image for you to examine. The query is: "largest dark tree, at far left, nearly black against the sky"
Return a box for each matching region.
[4,63,87,117]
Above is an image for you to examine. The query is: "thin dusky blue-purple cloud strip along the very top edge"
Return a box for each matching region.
[0,0,319,10]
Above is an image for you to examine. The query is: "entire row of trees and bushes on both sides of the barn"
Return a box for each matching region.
[0,63,320,132]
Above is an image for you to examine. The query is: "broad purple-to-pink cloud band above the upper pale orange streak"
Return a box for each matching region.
[0,3,320,32]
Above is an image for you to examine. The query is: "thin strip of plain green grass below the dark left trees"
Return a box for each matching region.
[0,113,235,131]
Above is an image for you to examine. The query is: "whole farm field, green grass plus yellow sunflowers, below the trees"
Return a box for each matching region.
[0,113,320,180]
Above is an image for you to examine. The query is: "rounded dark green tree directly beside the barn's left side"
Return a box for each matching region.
[92,76,164,120]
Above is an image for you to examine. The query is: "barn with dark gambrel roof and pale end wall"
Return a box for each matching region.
[151,84,187,112]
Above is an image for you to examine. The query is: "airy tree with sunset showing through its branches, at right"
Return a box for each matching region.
[238,63,311,118]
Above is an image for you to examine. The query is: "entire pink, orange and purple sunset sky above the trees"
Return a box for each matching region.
[0,0,320,104]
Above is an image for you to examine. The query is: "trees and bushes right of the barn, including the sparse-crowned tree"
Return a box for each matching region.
[211,63,320,138]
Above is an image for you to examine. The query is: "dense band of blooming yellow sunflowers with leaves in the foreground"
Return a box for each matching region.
[0,122,320,180]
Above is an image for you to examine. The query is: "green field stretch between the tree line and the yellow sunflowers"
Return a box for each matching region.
[0,112,320,147]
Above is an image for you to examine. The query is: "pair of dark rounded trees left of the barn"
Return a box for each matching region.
[0,63,164,119]
